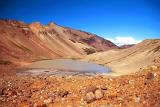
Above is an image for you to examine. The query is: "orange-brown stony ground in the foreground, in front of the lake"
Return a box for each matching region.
[0,65,160,107]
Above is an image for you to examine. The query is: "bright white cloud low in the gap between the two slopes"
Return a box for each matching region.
[106,36,142,46]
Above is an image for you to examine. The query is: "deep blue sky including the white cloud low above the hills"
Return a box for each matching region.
[0,0,160,44]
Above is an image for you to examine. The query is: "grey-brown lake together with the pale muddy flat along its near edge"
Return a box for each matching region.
[20,59,111,76]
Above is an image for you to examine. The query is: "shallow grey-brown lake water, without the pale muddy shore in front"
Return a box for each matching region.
[29,59,111,73]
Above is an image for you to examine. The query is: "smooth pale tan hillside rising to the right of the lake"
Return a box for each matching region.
[83,39,160,75]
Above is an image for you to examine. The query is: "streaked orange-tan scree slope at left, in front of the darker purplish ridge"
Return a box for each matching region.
[0,22,84,59]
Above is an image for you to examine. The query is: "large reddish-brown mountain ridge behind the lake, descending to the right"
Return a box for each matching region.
[0,20,118,61]
